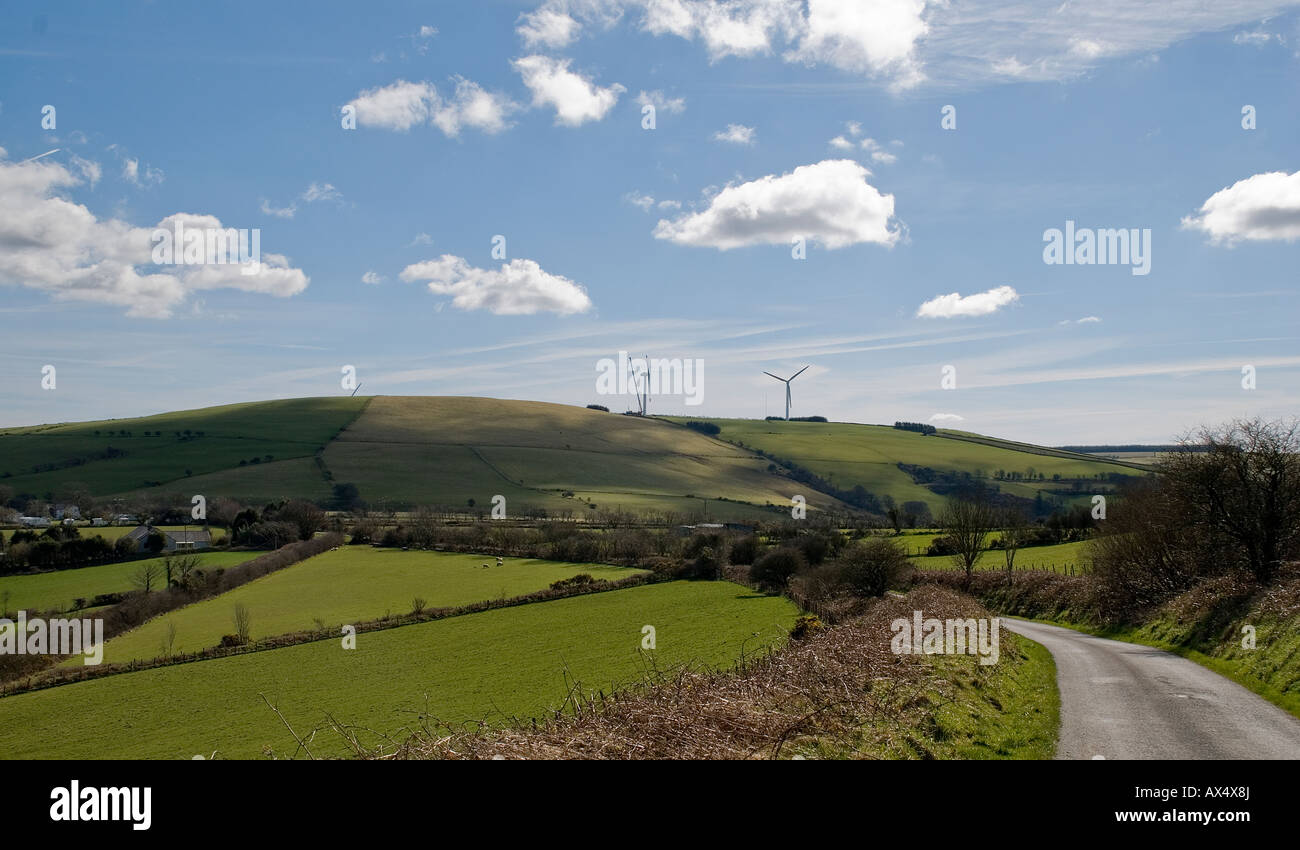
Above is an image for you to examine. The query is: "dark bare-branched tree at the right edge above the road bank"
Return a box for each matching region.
[1157,419,1300,584]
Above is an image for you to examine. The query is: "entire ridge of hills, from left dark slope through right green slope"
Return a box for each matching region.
[0,396,1141,520]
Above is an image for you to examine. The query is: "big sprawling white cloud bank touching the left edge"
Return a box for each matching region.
[0,154,309,318]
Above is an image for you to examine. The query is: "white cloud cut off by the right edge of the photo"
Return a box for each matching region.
[1183,172,1300,244]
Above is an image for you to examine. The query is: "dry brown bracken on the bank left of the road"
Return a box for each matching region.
[356,586,1003,759]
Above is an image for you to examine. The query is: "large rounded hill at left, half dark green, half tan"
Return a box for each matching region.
[0,396,844,520]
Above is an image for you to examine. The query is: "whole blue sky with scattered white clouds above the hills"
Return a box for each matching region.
[0,0,1300,444]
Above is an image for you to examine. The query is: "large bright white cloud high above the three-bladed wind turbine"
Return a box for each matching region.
[654,160,900,251]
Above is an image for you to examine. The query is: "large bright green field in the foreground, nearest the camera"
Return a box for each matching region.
[0,582,798,759]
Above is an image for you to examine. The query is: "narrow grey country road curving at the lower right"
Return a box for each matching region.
[1002,617,1300,759]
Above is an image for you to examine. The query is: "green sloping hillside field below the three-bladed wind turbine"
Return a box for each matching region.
[672,417,1143,513]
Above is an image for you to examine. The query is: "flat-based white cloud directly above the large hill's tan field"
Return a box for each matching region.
[400,253,592,316]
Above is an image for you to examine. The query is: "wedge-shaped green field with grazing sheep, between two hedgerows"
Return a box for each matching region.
[91,546,641,664]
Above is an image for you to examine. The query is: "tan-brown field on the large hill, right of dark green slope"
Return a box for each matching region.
[325,396,833,519]
